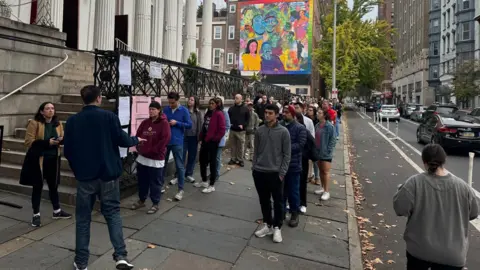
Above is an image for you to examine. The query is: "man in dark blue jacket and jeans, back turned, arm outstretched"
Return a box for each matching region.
[64,85,145,269]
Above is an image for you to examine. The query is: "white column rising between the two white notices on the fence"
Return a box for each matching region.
[134,0,152,54]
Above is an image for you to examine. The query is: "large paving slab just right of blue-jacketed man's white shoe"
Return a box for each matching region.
[131,220,247,263]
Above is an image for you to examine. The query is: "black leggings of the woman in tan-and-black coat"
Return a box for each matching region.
[32,157,60,214]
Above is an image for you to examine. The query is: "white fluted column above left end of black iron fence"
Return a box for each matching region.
[93,0,115,50]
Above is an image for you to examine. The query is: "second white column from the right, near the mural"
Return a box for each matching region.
[183,0,198,63]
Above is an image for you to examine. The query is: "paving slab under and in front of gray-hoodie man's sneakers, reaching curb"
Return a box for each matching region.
[249,228,349,269]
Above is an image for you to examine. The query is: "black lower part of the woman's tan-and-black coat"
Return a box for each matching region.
[20,140,60,186]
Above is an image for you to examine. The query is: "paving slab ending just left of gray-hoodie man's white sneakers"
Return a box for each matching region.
[160,207,257,239]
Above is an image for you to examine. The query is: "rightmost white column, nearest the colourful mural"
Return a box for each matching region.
[200,0,213,69]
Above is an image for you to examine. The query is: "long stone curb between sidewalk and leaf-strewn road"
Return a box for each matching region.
[342,116,363,270]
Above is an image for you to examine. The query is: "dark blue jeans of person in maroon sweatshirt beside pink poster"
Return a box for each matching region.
[137,163,164,204]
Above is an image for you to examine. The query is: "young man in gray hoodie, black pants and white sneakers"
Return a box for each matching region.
[252,104,291,243]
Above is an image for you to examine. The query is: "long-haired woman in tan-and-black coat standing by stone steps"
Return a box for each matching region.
[20,102,72,227]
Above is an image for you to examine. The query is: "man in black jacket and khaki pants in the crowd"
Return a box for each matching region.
[228,94,250,167]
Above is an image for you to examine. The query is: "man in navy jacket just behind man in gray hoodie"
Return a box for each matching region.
[283,105,307,227]
